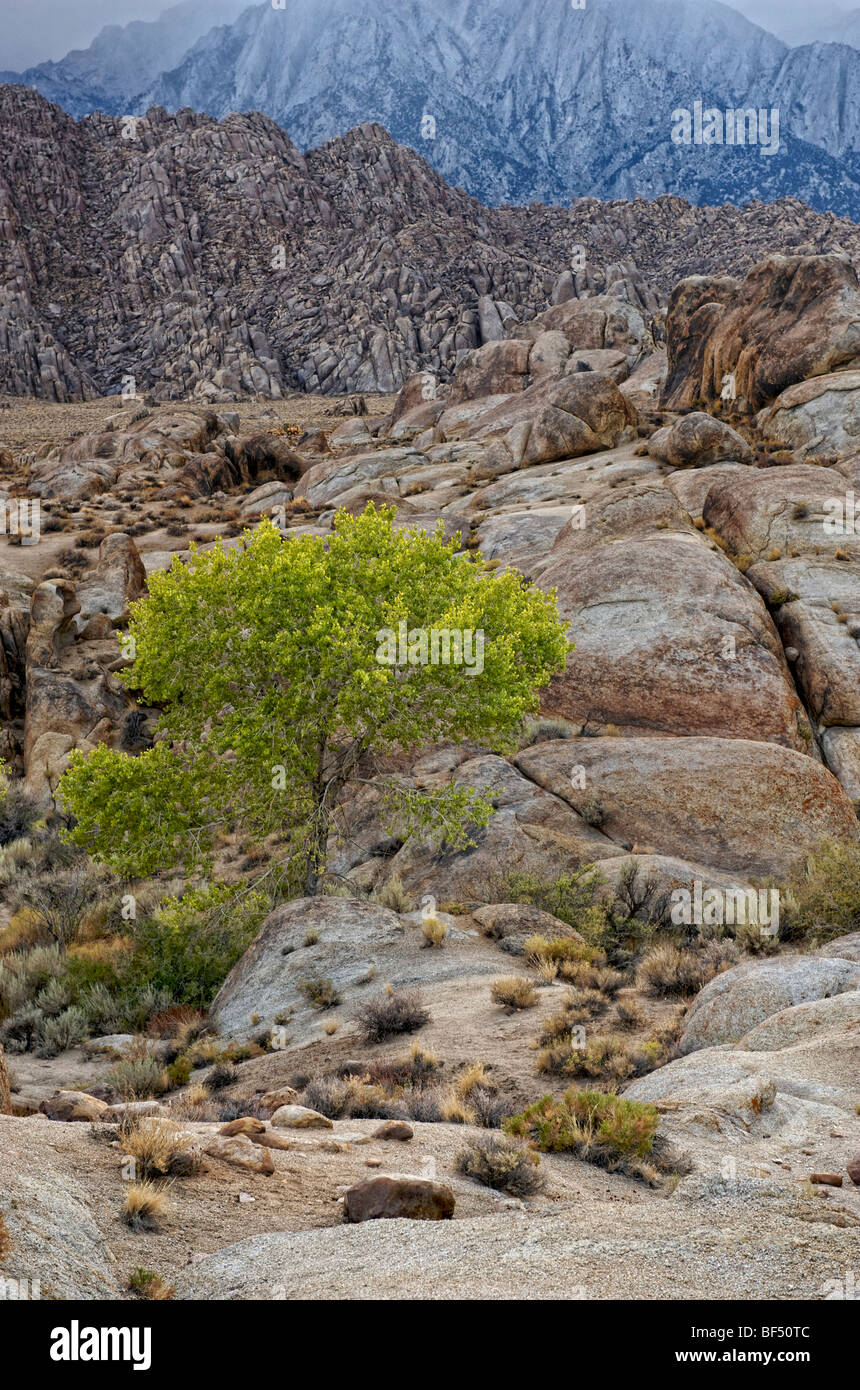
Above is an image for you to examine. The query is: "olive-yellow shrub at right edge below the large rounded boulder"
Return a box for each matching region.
[781,840,860,941]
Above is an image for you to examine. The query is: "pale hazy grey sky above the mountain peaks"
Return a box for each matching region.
[0,0,860,71]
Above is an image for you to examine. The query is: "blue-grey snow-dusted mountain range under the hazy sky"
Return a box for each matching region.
[5,0,860,212]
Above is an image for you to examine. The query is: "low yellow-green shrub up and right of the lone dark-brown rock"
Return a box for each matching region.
[503,1088,659,1172]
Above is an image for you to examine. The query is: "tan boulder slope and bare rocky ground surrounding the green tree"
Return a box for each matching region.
[0,244,860,1298]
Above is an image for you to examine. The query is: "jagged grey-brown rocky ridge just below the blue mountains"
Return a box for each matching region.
[0,86,860,400]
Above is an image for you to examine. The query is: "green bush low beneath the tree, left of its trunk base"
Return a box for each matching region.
[129,884,265,1009]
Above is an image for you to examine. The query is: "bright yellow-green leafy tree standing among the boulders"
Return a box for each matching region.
[60,505,568,894]
